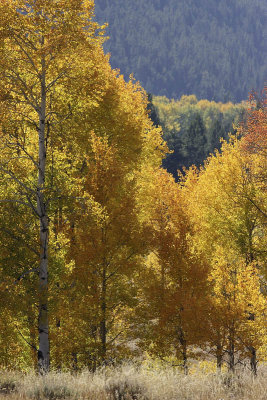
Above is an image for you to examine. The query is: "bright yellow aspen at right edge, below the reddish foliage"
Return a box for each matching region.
[184,137,266,372]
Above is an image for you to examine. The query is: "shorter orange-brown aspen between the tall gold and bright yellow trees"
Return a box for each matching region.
[135,169,208,373]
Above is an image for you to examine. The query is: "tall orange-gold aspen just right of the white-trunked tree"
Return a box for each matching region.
[48,71,166,368]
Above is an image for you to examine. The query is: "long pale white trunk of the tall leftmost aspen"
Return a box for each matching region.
[37,54,50,374]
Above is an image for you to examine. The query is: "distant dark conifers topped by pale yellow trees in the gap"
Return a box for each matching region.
[149,95,246,177]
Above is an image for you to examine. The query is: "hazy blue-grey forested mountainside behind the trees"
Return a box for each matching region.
[96,0,267,102]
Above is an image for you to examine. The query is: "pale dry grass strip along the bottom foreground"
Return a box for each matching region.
[0,365,267,400]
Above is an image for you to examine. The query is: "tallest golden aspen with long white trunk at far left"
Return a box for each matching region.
[0,0,107,371]
